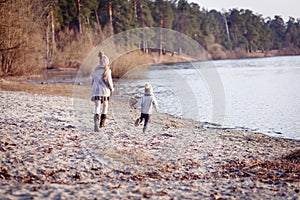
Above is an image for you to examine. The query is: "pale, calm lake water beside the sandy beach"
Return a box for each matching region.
[115,56,300,139]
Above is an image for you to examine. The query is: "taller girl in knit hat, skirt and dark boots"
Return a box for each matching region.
[91,51,114,132]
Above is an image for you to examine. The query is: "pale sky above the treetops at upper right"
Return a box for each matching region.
[188,0,300,22]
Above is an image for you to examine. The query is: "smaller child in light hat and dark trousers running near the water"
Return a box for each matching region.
[133,83,158,133]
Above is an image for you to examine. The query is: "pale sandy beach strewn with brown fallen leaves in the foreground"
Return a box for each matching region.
[0,91,300,200]
